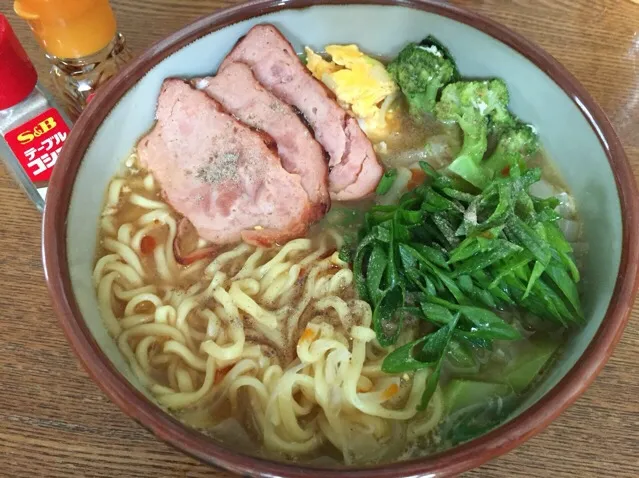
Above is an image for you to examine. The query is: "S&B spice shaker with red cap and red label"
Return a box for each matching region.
[0,14,71,211]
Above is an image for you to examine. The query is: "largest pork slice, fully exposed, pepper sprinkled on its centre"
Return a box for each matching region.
[137,79,313,246]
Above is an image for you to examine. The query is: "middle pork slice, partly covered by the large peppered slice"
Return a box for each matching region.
[192,63,330,220]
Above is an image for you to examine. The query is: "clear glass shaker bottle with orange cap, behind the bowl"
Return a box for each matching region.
[13,0,131,120]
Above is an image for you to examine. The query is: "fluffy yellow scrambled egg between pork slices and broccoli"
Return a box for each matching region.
[305,45,398,133]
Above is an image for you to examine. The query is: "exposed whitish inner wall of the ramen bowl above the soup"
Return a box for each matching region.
[67,5,622,448]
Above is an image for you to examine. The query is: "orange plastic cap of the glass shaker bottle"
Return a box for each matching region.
[13,0,116,58]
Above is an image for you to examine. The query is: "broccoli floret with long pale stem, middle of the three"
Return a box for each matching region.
[435,79,514,189]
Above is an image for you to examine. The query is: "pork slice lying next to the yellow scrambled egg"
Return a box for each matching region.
[219,25,383,200]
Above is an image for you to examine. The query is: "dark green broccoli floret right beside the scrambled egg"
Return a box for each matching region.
[388,36,459,117]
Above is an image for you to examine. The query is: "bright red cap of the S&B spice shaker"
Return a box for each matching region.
[0,13,38,110]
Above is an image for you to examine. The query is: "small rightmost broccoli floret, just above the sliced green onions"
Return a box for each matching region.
[482,122,539,177]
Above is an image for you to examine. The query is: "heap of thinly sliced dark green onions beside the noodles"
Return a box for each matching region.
[353,163,583,408]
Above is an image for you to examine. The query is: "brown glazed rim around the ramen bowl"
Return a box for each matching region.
[42,0,639,478]
